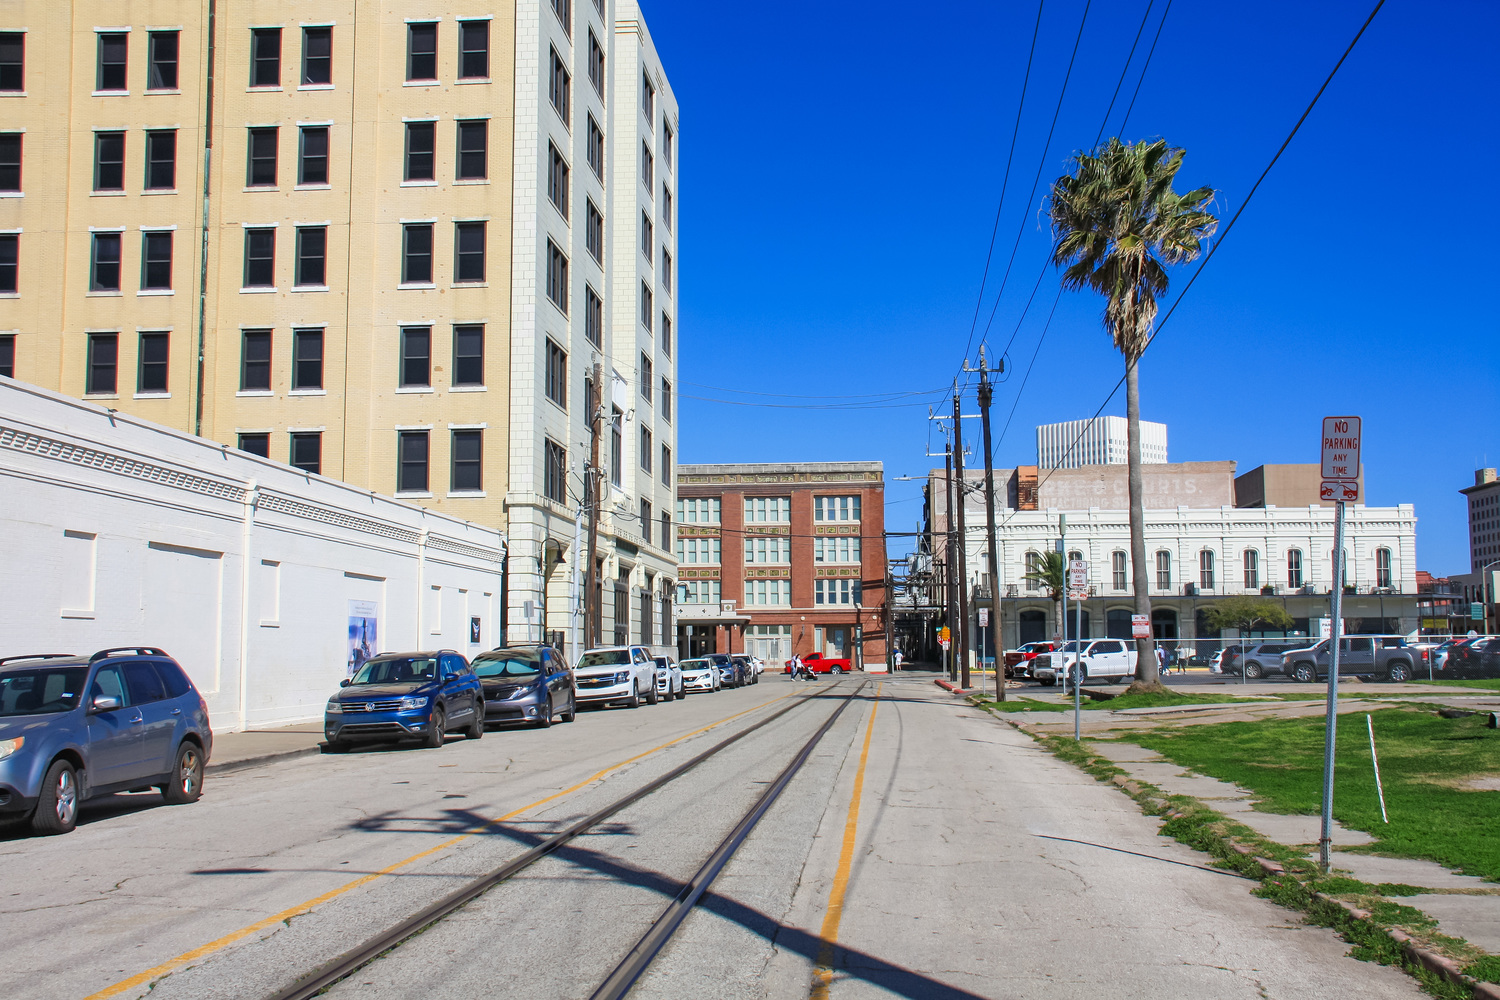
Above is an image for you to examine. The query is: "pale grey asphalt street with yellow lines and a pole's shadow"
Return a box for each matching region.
[0,675,1422,1000]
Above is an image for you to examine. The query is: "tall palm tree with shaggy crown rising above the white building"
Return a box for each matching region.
[1050,138,1218,688]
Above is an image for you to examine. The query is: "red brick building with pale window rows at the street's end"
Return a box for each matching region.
[677,462,888,670]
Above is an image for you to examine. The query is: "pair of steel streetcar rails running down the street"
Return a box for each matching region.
[267,682,869,1000]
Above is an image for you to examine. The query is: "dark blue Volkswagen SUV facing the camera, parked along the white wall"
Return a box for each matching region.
[323,649,485,753]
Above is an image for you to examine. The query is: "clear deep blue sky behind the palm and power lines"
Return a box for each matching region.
[642,0,1500,576]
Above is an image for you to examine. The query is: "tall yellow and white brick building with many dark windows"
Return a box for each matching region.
[0,0,678,645]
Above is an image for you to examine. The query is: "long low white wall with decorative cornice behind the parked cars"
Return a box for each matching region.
[0,378,506,732]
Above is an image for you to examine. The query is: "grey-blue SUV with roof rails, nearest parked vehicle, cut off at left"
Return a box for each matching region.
[0,646,213,834]
